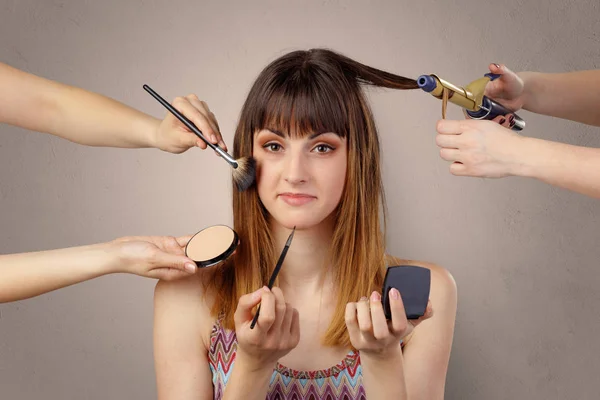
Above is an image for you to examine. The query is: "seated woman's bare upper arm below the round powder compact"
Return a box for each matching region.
[154,275,214,400]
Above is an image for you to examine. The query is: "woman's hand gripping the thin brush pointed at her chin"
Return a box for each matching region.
[234,286,300,371]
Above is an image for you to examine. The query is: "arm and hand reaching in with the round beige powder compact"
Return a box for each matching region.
[0,236,196,303]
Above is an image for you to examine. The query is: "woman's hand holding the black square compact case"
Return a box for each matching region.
[345,288,433,357]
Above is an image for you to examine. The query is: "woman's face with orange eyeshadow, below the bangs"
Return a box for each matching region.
[252,129,348,229]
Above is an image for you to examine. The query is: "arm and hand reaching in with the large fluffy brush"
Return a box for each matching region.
[0,63,226,153]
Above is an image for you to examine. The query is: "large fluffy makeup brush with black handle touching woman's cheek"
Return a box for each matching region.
[144,85,256,192]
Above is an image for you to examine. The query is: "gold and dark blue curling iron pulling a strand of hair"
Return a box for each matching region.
[417,74,525,131]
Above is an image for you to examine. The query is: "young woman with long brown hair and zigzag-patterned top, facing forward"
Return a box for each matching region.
[154,49,456,400]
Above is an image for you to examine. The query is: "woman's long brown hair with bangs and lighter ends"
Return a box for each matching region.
[209,49,418,346]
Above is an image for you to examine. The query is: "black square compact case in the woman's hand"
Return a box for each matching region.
[382,265,431,319]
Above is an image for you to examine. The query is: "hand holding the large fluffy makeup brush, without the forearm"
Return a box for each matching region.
[154,94,227,154]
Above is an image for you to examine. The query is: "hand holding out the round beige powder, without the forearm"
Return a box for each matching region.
[107,236,196,281]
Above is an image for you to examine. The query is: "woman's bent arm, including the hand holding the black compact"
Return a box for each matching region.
[345,259,456,400]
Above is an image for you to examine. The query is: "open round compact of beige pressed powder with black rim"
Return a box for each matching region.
[185,225,238,268]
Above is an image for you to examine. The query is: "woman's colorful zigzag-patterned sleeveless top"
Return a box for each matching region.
[208,318,406,400]
